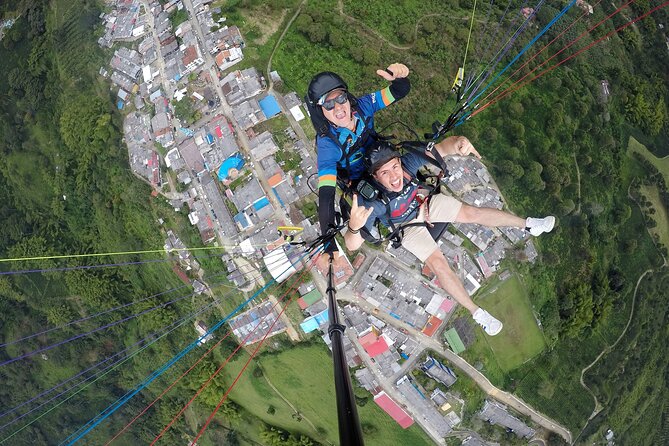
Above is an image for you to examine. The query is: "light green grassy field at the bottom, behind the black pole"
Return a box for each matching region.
[223,344,432,446]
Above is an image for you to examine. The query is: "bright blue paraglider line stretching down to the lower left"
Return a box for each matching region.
[60,246,320,446]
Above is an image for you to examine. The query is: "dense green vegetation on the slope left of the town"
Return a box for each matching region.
[0,0,259,445]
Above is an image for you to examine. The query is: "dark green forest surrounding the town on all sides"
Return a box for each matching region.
[0,0,669,445]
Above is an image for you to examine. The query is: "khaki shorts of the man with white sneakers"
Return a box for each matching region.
[402,194,462,262]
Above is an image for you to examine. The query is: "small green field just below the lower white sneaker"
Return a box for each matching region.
[463,275,546,376]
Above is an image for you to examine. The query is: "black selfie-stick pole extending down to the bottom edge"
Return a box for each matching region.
[327,255,364,446]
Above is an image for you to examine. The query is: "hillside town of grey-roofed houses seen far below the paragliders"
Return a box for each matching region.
[98,0,538,445]
